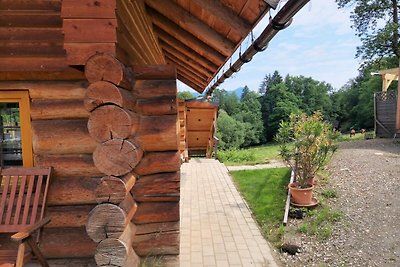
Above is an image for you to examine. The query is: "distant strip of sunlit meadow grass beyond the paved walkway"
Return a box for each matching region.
[218,143,279,166]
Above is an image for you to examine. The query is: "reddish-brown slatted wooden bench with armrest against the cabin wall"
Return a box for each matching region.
[0,167,52,267]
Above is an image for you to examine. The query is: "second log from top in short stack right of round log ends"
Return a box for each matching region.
[132,80,177,101]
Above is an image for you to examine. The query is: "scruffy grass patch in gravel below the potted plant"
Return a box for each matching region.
[298,207,343,240]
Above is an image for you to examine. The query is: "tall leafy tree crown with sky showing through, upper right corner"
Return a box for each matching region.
[336,0,400,60]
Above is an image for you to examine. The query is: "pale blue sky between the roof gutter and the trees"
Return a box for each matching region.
[178,0,360,94]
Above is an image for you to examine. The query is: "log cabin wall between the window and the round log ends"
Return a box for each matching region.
[0,80,101,258]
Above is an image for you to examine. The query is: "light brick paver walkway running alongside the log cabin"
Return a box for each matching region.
[180,159,278,267]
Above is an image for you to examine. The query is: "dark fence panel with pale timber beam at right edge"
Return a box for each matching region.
[374,68,400,138]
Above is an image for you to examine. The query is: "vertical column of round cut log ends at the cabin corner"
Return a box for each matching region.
[84,54,143,266]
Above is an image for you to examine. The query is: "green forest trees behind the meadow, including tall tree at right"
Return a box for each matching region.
[178,0,400,149]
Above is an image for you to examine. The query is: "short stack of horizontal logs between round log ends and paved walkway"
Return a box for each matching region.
[131,65,181,257]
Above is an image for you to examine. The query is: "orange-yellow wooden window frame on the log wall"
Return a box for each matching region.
[0,92,33,167]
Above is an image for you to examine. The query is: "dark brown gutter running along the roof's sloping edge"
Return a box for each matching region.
[206,0,310,95]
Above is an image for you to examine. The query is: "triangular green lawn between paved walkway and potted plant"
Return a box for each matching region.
[231,168,290,245]
